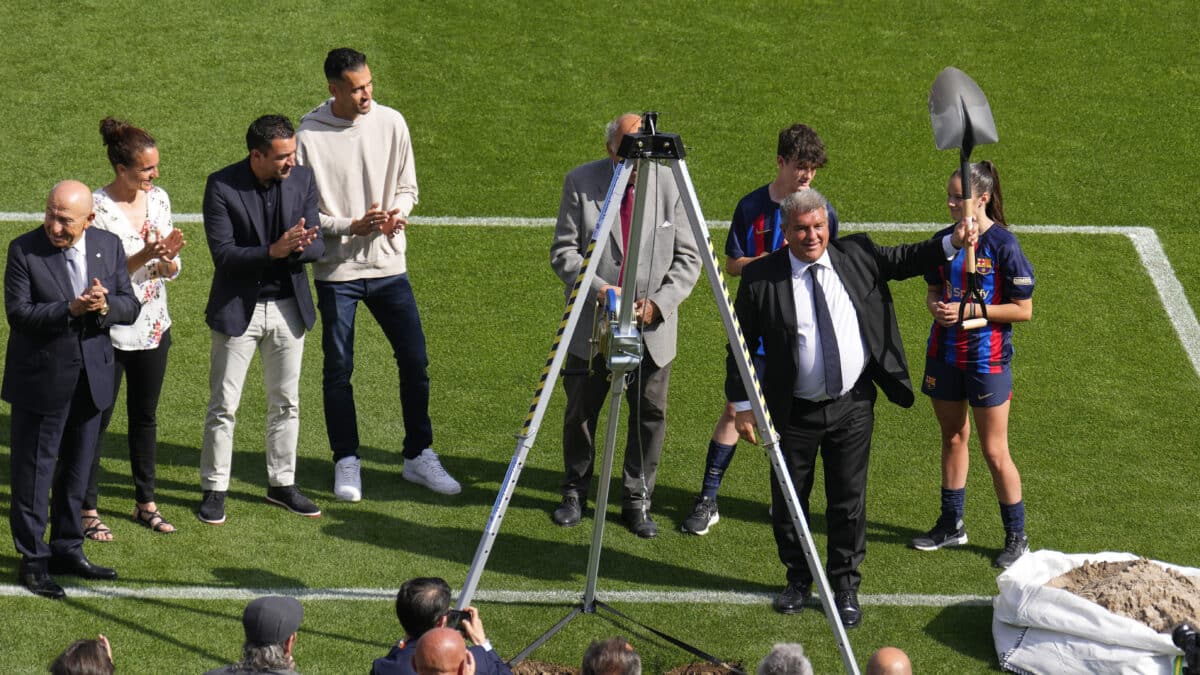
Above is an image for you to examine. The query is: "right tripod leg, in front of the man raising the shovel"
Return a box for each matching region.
[672,160,859,675]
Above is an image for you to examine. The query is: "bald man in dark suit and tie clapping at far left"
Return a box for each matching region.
[2,180,140,599]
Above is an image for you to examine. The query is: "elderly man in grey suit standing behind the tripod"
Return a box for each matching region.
[550,113,700,538]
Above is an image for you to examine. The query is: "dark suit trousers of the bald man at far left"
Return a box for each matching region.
[8,369,100,565]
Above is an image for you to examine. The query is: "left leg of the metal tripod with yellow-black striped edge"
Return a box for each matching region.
[456,162,634,609]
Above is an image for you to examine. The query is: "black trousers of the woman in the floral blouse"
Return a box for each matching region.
[83,328,170,510]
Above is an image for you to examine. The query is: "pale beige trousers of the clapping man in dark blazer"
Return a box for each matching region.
[200,298,305,491]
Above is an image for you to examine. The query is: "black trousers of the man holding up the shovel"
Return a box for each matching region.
[770,375,876,592]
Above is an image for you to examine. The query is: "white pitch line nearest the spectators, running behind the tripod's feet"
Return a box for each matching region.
[0,584,991,607]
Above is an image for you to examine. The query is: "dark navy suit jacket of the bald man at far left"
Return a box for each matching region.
[0,227,142,414]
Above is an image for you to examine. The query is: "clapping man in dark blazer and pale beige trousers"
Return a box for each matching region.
[197,115,325,525]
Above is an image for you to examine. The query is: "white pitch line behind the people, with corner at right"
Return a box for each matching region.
[0,211,1200,376]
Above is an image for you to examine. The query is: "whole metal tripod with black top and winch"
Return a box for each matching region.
[456,113,859,675]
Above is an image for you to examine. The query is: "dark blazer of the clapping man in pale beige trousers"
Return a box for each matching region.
[204,157,325,336]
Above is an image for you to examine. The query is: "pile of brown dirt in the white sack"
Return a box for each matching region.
[1046,558,1200,633]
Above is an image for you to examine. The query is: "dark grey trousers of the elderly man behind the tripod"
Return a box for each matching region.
[560,354,671,509]
